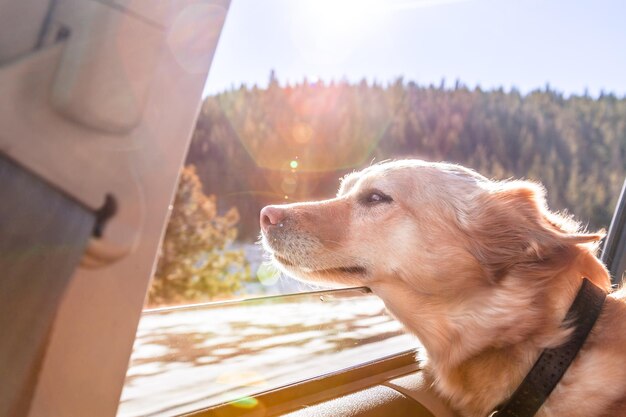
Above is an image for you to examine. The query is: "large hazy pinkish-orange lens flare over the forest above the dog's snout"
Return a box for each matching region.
[216,84,392,172]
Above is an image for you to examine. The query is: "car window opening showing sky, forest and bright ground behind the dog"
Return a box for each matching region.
[120,0,626,416]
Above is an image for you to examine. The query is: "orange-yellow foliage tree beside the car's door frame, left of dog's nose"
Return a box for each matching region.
[148,165,250,305]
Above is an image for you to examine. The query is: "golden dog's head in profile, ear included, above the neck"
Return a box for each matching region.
[261,160,600,294]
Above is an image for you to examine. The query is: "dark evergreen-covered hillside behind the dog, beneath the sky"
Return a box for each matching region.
[187,79,626,239]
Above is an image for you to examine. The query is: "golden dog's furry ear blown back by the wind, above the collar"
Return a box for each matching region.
[465,181,602,281]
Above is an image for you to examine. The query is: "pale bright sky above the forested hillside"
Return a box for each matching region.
[204,0,626,96]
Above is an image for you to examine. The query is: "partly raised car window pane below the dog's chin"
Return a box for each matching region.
[118,289,418,417]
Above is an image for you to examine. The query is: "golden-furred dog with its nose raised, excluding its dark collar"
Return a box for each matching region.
[260,160,626,417]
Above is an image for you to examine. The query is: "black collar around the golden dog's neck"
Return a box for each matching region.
[489,278,606,417]
